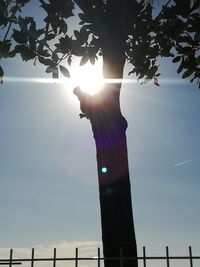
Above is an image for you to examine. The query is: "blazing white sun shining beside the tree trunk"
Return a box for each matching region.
[70,60,104,95]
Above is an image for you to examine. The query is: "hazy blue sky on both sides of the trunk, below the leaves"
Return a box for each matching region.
[0,0,200,264]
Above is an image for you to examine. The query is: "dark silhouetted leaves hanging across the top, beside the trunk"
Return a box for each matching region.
[0,0,200,88]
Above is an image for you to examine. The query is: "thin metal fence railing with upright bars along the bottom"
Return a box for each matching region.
[0,246,200,267]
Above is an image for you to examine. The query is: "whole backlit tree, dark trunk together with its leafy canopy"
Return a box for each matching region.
[0,0,200,267]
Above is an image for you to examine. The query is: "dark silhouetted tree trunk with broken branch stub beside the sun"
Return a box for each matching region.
[75,0,138,267]
